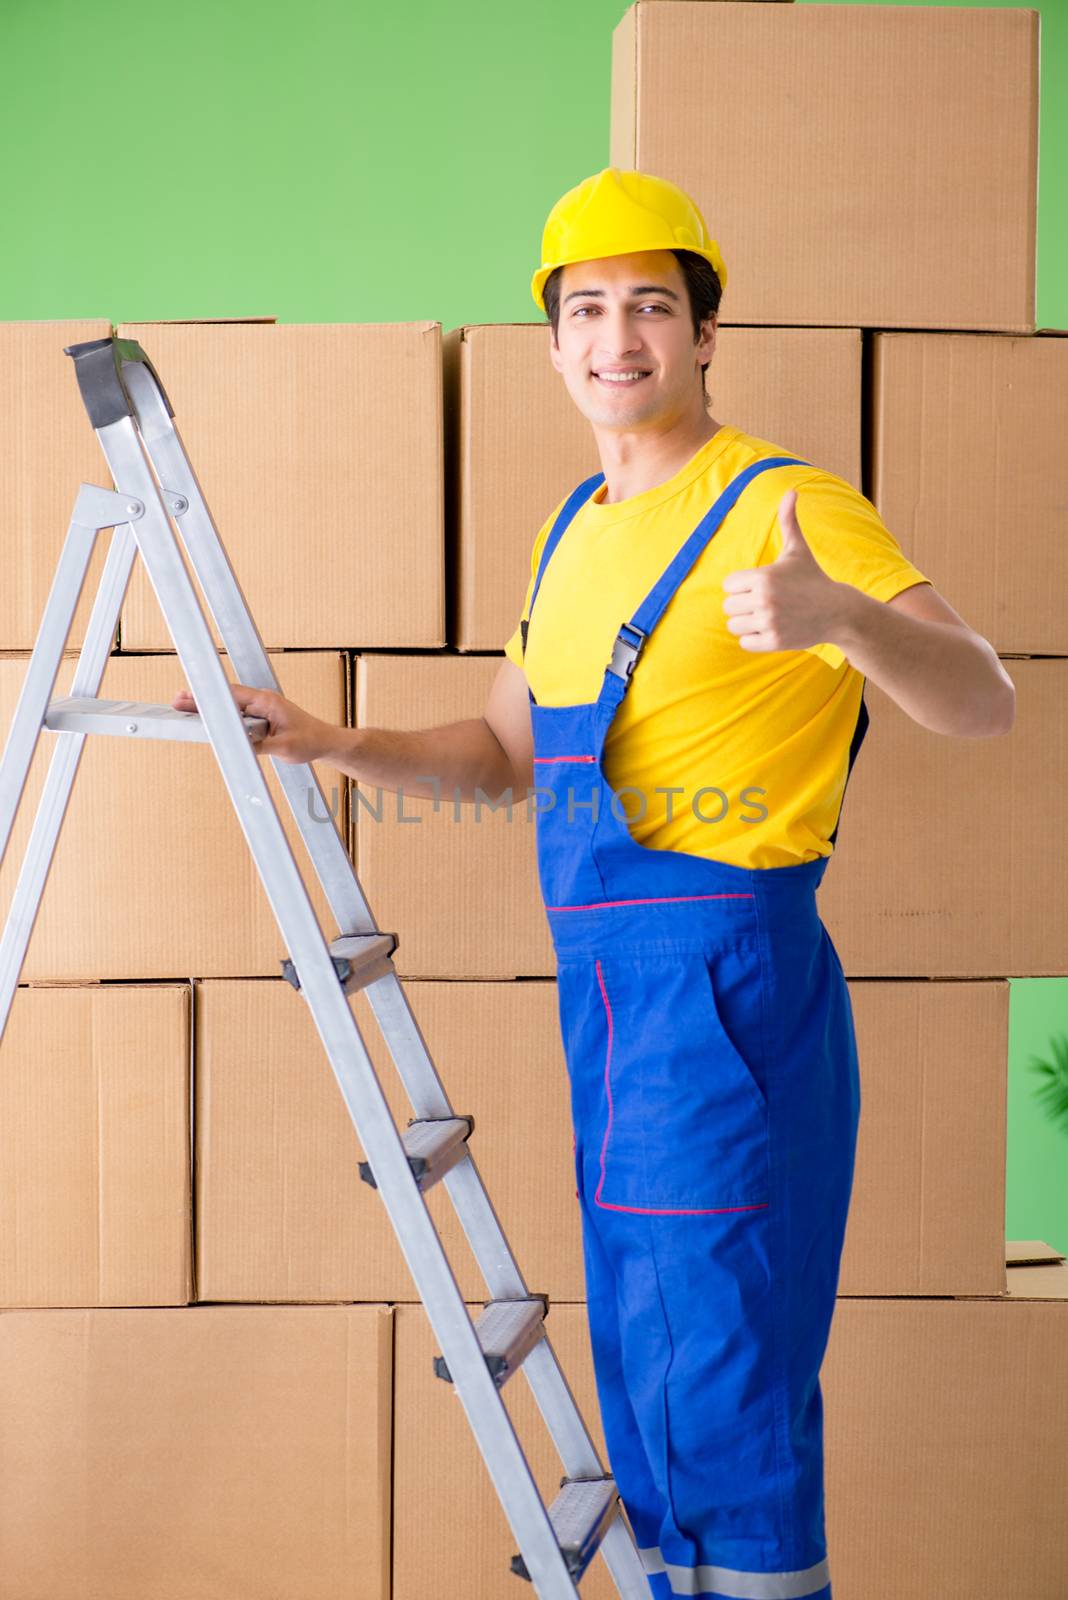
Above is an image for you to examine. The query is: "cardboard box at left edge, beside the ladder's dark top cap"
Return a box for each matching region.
[0,317,112,650]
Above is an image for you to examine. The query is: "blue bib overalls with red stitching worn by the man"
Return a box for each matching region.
[523,456,867,1600]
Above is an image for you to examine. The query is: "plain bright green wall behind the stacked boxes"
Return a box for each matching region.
[0,0,1068,1253]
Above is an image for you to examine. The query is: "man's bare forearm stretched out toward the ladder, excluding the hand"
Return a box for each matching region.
[323,717,515,802]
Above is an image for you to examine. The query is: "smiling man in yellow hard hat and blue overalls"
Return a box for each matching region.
[174,168,1015,1600]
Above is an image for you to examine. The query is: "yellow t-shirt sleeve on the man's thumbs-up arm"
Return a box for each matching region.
[772,474,931,667]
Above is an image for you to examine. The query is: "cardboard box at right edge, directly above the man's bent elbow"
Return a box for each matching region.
[871,333,1068,656]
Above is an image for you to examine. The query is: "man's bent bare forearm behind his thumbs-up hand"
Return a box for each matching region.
[830,584,1015,739]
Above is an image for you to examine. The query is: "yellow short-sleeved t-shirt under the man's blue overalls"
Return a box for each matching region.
[504,427,929,867]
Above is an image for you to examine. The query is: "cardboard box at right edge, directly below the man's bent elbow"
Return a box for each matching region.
[819,659,1068,978]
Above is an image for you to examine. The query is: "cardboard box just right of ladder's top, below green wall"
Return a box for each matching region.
[118,322,444,650]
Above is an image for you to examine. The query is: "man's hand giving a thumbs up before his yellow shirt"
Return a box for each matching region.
[723,490,849,650]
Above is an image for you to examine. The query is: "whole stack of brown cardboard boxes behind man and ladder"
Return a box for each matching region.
[0,0,1068,1600]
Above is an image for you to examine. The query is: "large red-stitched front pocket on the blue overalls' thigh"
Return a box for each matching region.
[582,949,769,1214]
